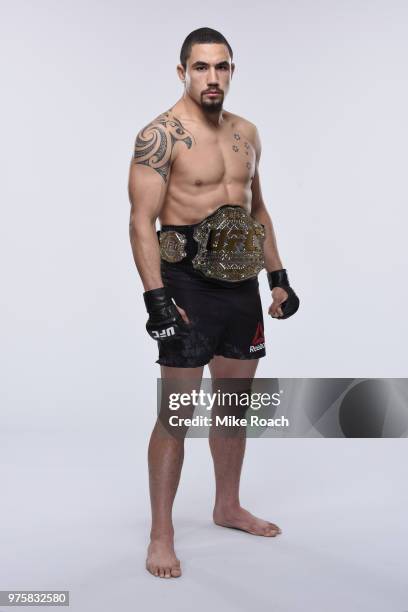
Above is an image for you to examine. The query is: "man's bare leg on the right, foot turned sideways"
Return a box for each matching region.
[209,355,281,536]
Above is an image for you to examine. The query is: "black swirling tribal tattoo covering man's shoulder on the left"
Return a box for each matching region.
[133,111,194,183]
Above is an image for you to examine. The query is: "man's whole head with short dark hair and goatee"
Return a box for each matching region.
[177,28,235,113]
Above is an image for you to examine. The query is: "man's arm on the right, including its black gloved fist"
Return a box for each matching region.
[251,128,299,319]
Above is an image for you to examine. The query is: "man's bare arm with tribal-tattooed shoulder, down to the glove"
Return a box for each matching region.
[129,121,172,291]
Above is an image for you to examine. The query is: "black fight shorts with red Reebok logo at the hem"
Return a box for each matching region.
[156,260,265,368]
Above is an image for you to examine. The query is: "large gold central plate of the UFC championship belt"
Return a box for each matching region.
[192,204,265,282]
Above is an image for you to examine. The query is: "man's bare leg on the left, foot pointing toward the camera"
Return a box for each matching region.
[146,366,204,578]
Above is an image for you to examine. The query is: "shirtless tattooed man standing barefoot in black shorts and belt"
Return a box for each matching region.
[129,28,299,578]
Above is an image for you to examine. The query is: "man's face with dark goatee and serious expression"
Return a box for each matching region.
[179,43,235,113]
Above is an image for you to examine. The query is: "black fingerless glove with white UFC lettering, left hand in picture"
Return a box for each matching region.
[143,287,189,340]
